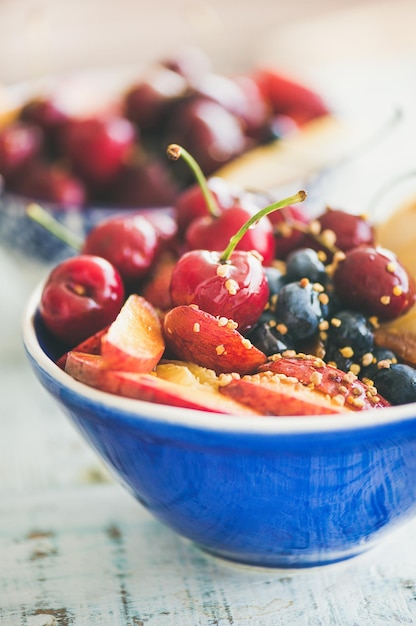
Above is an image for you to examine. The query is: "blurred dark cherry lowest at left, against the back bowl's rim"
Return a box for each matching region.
[10,161,86,208]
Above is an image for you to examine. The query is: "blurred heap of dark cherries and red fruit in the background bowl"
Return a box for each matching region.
[0,51,328,207]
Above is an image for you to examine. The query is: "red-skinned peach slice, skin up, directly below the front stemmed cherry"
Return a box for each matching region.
[164,305,267,374]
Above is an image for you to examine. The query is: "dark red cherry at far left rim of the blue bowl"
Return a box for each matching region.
[39,255,124,346]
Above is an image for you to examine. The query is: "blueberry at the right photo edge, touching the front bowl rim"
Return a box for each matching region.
[374,363,416,404]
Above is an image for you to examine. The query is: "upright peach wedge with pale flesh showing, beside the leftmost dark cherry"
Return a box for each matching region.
[101,294,165,372]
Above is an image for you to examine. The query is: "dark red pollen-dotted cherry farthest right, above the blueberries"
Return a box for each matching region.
[333,246,415,321]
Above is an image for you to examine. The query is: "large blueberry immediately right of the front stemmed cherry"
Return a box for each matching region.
[274,281,323,342]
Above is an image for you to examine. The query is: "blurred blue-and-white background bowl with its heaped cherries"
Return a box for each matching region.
[0,51,329,264]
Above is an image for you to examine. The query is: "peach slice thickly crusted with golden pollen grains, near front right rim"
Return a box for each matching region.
[259,354,389,411]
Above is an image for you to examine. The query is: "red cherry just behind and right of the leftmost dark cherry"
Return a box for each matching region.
[82,214,159,287]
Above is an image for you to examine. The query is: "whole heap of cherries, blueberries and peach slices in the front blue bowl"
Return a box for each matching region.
[35,145,416,415]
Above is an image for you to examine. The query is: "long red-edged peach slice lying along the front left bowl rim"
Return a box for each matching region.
[66,352,260,415]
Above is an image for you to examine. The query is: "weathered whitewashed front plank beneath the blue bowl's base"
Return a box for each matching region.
[0,484,416,626]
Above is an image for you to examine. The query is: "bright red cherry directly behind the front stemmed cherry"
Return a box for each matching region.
[185,203,275,265]
